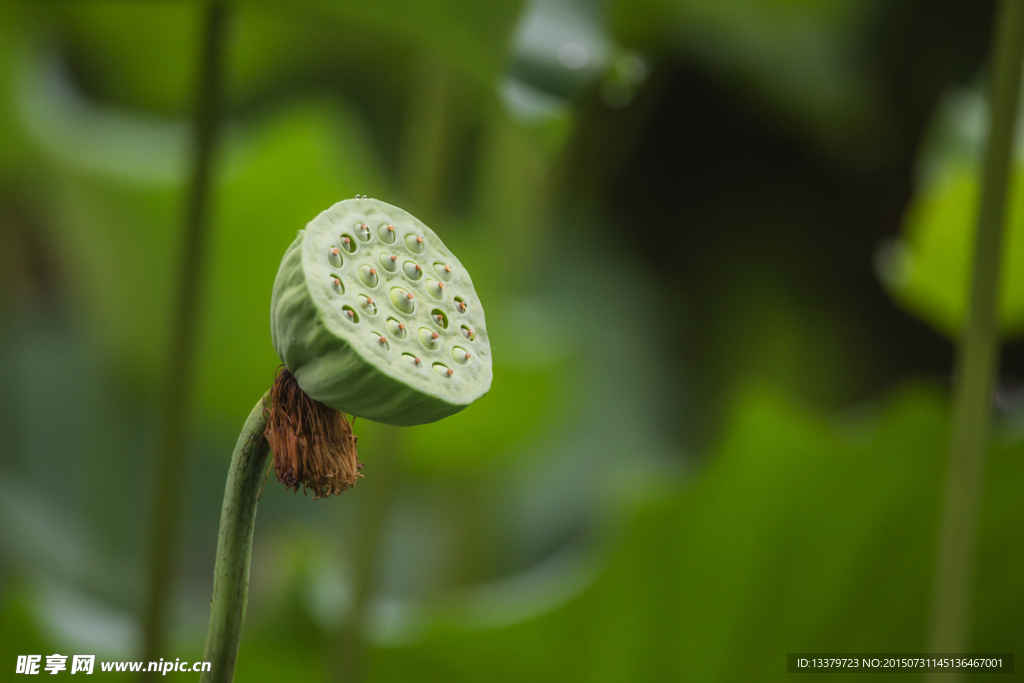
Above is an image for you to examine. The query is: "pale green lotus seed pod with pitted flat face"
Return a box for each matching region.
[270,194,492,425]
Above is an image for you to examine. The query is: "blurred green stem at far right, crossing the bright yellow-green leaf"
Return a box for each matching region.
[929,0,1024,680]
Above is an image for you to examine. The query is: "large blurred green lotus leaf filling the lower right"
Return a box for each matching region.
[370,388,1024,683]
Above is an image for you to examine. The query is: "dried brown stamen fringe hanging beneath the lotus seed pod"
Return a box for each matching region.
[264,367,362,500]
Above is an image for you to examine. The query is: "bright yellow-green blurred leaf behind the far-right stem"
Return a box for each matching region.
[879,87,1024,337]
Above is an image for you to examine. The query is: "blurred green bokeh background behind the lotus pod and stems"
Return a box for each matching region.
[0,0,1024,682]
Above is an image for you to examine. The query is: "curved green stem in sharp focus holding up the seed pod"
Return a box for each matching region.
[200,391,270,683]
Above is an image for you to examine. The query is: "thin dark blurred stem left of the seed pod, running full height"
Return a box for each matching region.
[142,0,227,679]
